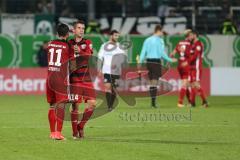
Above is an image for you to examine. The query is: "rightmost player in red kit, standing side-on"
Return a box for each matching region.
[190,31,208,107]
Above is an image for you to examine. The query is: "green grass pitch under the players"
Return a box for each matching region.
[0,96,240,160]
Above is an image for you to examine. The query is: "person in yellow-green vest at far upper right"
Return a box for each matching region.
[221,15,238,35]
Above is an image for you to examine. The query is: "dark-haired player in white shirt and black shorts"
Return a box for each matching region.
[98,30,127,111]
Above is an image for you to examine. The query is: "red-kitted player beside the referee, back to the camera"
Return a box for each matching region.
[170,30,192,108]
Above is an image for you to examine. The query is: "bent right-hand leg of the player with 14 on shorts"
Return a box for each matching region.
[78,99,96,138]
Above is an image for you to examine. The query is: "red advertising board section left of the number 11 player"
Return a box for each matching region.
[0,68,47,95]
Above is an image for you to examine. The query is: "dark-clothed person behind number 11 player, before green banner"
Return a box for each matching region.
[37,41,48,67]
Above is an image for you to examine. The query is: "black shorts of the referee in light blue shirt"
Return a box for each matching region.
[147,59,162,80]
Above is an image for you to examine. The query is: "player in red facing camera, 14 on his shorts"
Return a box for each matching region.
[69,20,96,139]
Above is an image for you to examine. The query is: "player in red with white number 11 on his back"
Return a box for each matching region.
[46,24,69,140]
